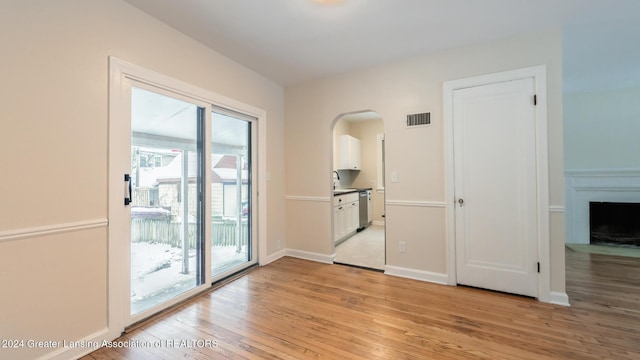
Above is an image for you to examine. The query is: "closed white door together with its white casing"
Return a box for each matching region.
[444,66,550,302]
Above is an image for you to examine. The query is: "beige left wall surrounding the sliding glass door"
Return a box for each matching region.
[0,0,285,359]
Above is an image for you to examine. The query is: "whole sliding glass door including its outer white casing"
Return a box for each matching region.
[108,58,266,338]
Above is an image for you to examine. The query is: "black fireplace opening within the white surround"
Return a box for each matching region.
[589,202,640,247]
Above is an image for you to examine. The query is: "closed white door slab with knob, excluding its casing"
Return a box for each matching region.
[453,78,538,297]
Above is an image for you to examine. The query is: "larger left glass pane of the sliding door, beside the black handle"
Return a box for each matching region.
[131,87,204,316]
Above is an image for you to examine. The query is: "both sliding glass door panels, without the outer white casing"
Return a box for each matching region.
[124,80,257,324]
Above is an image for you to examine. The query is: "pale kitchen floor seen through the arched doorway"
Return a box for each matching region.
[335,225,385,270]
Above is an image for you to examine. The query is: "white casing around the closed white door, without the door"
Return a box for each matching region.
[443,65,551,302]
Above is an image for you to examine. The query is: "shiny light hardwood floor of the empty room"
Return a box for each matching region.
[85,249,640,360]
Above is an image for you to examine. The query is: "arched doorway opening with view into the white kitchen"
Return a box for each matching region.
[330,111,386,270]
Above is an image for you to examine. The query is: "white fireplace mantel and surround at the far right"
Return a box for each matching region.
[564,169,640,244]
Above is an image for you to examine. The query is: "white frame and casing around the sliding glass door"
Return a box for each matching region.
[104,56,267,334]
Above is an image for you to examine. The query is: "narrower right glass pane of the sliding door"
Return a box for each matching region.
[211,111,253,278]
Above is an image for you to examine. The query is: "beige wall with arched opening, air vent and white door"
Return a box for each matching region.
[285,29,564,292]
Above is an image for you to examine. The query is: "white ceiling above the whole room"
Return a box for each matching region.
[126,0,640,86]
